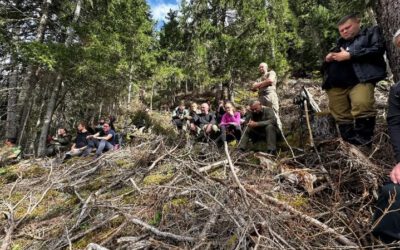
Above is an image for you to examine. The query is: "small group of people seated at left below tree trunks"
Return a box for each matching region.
[47,118,119,160]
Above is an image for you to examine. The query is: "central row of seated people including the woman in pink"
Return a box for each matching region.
[172,100,279,155]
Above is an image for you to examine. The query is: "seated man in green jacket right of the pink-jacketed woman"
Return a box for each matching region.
[239,100,278,155]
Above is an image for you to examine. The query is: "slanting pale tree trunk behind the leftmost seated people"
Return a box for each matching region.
[38,0,82,156]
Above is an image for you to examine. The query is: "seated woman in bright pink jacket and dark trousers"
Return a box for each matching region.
[219,102,242,142]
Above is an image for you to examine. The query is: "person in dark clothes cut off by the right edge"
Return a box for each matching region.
[372,29,400,243]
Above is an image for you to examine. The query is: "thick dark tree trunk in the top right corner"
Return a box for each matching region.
[375,0,400,81]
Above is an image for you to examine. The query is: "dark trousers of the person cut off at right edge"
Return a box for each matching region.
[372,183,400,243]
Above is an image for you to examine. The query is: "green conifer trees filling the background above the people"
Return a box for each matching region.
[0,0,399,155]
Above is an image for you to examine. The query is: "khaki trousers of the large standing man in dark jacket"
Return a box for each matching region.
[327,83,376,124]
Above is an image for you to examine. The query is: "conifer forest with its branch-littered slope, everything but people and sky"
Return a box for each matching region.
[0,0,400,249]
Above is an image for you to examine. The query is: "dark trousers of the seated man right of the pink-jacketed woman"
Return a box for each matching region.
[239,124,278,150]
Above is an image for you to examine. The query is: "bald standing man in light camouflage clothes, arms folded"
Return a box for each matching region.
[251,63,279,115]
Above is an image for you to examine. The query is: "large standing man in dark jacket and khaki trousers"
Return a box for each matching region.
[322,14,386,145]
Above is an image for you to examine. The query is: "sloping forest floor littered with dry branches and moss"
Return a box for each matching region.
[0,80,394,249]
